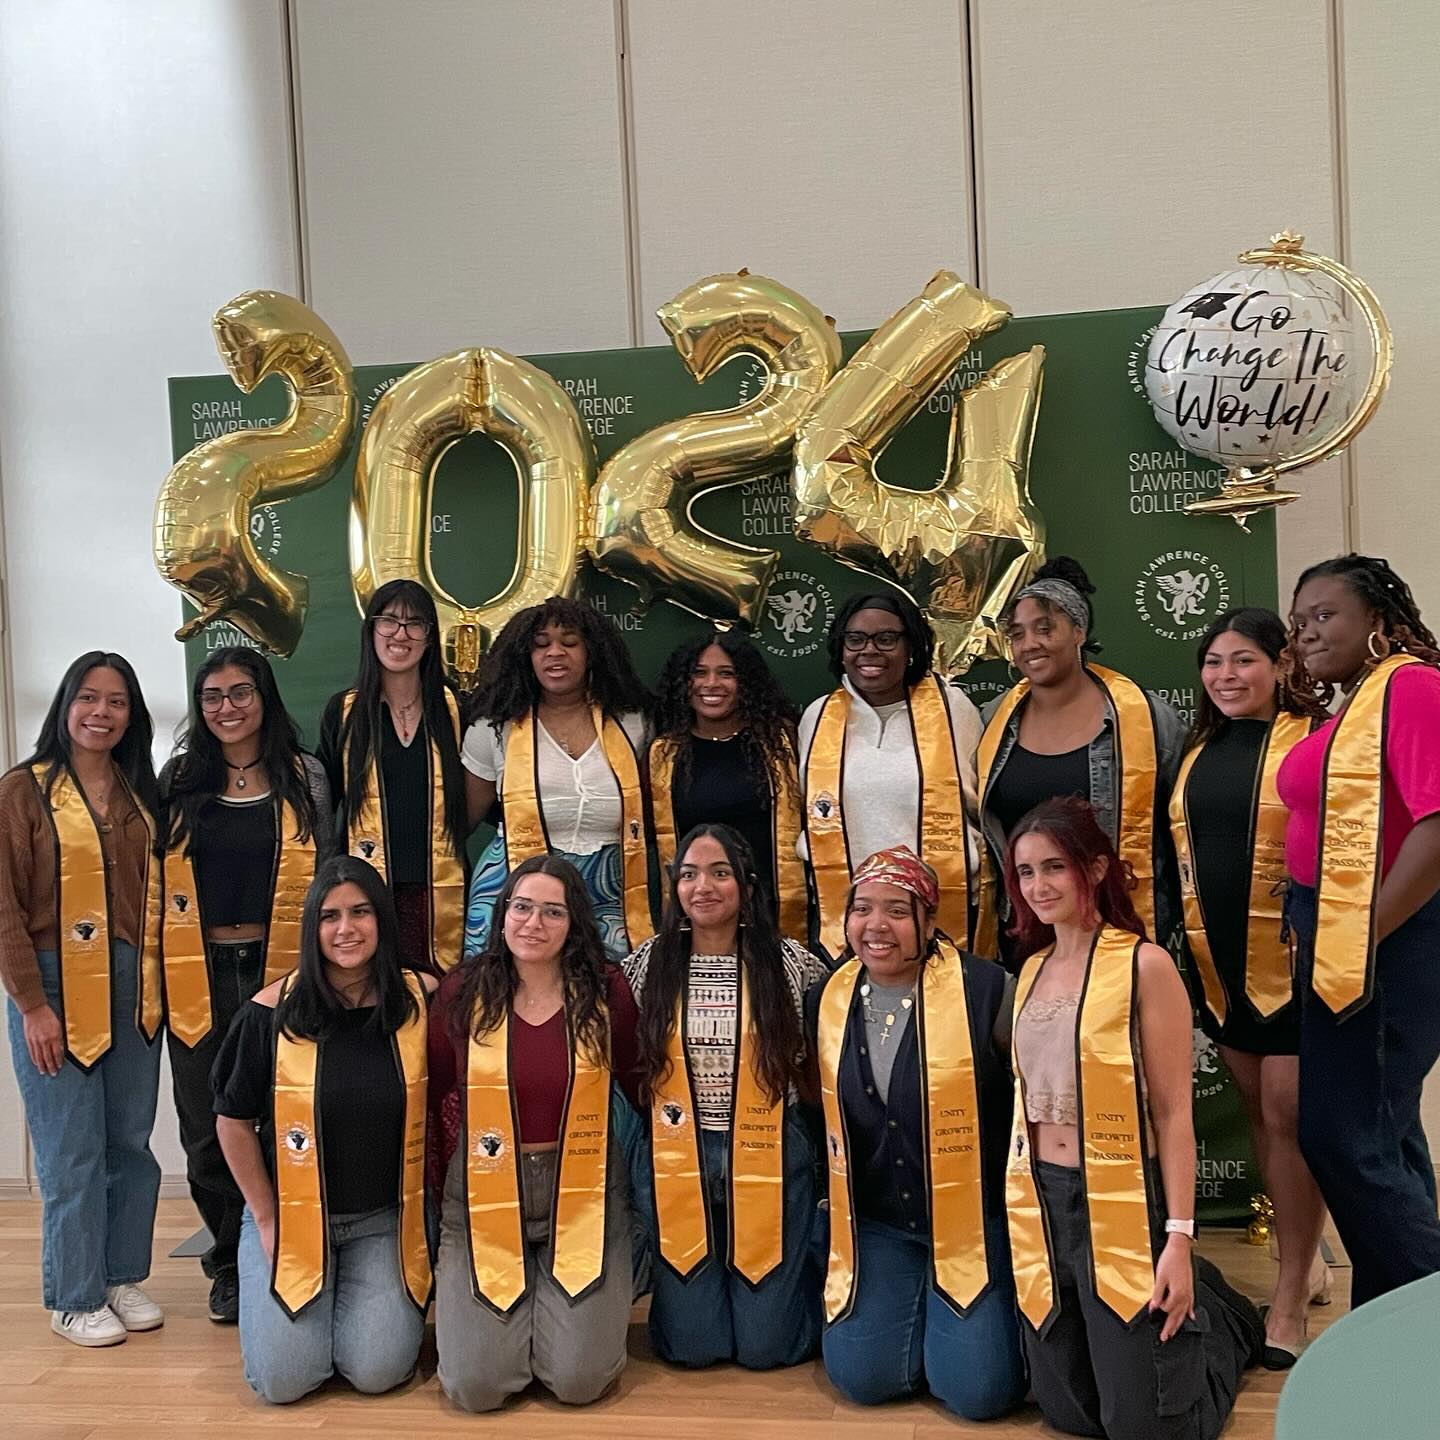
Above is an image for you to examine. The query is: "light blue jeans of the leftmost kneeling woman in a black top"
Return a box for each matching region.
[239,1205,425,1405]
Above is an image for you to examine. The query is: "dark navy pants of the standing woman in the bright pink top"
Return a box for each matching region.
[1289,886,1440,1308]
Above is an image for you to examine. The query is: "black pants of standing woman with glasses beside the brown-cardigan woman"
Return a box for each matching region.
[167,940,265,1276]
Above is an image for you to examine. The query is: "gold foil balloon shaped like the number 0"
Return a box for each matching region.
[350,348,595,690]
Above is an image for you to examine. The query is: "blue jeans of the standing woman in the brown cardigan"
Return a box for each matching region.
[7,940,160,1310]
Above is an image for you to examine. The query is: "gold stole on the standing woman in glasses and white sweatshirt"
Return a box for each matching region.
[805,674,984,956]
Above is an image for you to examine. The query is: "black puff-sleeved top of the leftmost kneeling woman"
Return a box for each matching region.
[210,999,405,1217]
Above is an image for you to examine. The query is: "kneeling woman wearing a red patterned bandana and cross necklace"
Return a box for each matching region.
[805,847,1025,1420]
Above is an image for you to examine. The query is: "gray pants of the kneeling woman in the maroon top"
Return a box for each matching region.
[435,1136,632,1411]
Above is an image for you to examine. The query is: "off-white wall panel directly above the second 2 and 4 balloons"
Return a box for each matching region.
[628,0,973,344]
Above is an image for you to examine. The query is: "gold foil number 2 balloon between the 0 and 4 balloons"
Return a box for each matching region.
[590,271,840,628]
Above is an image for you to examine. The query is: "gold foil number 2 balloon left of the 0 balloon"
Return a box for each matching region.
[154,289,356,655]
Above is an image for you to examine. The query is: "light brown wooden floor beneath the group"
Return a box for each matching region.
[0,1200,1349,1440]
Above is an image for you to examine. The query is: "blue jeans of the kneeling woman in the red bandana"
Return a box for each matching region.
[824,1220,1025,1420]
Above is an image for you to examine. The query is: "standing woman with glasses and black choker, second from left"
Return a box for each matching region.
[160,648,331,1325]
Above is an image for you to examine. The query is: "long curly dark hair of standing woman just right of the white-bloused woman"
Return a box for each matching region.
[654,629,799,795]
